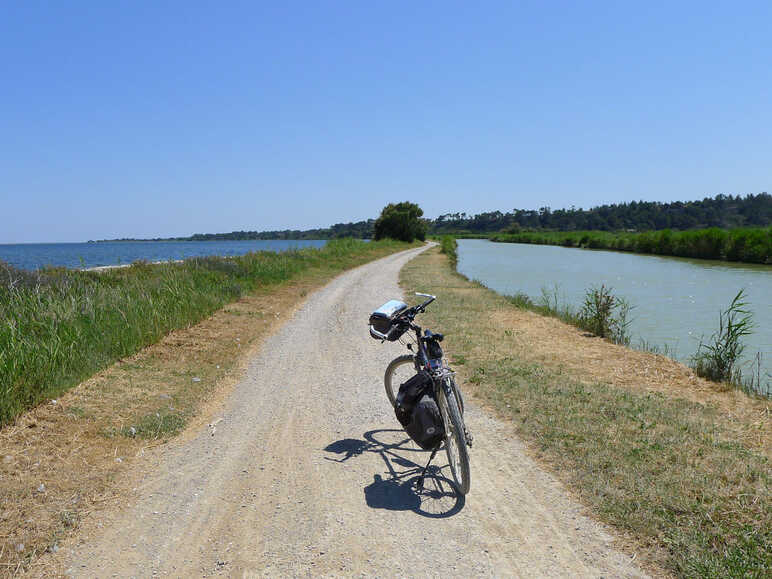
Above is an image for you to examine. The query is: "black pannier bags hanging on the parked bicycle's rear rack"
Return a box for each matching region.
[394,371,445,450]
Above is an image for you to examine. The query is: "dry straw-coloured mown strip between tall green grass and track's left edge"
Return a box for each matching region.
[0,242,411,575]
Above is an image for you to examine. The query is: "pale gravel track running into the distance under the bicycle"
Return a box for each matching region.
[52,250,641,577]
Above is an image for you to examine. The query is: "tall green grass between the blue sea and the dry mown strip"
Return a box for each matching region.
[0,239,408,430]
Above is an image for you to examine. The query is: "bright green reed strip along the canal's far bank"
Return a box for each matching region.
[491,227,772,264]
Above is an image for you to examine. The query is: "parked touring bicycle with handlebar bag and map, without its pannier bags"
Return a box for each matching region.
[370,292,473,495]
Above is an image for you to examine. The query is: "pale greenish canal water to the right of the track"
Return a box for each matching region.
[458,239,772,384]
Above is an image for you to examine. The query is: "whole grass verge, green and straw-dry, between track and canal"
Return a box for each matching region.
[401,251,772,577]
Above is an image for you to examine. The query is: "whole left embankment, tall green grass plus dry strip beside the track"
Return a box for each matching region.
[0,240,411,576]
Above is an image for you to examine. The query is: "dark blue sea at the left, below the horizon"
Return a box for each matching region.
[0,239,327,270]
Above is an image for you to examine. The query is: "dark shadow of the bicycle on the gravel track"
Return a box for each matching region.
[324,429,466,519]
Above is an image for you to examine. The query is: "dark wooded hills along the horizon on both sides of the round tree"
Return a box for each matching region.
[99,193,772,241]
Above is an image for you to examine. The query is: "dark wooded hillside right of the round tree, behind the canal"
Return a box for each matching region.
[429,193,772,235]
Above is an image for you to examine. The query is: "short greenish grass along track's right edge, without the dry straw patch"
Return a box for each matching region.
[401,248,772,577]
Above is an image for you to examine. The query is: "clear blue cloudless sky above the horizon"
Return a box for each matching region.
[0,0,772,243]
